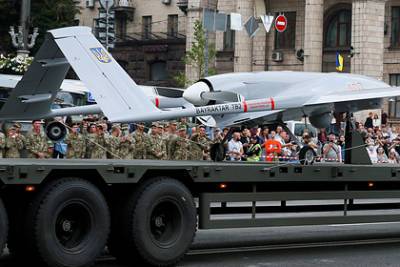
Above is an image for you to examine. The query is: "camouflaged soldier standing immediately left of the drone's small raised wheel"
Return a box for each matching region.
[26,120,48,159]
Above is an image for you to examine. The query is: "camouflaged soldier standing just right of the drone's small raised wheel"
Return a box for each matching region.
[64,124,86,159]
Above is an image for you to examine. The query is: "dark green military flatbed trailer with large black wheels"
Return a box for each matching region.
[0,159,400,267]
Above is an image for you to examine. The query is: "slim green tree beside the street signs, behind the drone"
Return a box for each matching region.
[174,20,216,87]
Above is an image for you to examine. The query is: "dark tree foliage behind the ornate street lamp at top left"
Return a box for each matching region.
[0,0,79,53]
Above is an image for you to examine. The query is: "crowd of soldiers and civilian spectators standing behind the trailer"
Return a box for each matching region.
[0,113,400,163]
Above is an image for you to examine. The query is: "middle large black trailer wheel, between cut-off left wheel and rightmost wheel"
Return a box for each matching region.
[29,178,110,267]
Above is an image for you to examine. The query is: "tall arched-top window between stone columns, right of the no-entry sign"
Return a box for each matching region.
[325,9,351,48]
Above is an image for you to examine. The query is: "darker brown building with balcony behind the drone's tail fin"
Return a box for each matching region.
[78,0,186,86]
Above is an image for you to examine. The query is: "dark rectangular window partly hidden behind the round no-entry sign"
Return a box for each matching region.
[275,12,296,49]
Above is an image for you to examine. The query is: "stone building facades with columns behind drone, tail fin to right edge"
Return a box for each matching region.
[75,0,400,121]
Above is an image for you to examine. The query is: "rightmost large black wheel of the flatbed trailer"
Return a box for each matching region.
[126,178,197,266]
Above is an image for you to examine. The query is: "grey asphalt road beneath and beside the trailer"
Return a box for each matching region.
[0,223,400,267]
